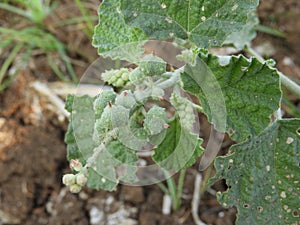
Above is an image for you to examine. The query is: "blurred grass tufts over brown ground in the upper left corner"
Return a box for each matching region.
[0,0,100,92]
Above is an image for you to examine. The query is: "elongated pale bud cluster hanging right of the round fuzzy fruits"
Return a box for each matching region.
[170,93,195,130]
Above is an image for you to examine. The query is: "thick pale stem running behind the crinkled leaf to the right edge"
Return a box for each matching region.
[246,46,300,97]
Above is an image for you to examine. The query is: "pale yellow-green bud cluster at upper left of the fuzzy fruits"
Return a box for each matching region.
[102,68,129,87]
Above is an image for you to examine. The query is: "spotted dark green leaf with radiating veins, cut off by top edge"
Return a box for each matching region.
[120,0,259,48]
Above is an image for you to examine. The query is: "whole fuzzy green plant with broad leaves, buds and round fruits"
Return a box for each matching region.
[63,0,300,225]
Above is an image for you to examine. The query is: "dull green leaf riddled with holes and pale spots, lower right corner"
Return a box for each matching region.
[215,119,300,225]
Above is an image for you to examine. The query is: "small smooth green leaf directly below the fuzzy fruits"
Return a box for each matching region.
[152,118,203,171]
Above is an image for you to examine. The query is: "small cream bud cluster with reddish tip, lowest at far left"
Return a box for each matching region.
[62,159,88,193]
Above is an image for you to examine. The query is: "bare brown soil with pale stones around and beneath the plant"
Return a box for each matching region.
[0,0,300,225]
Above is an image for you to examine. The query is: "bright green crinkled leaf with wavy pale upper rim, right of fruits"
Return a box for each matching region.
[181,51,281,141]
